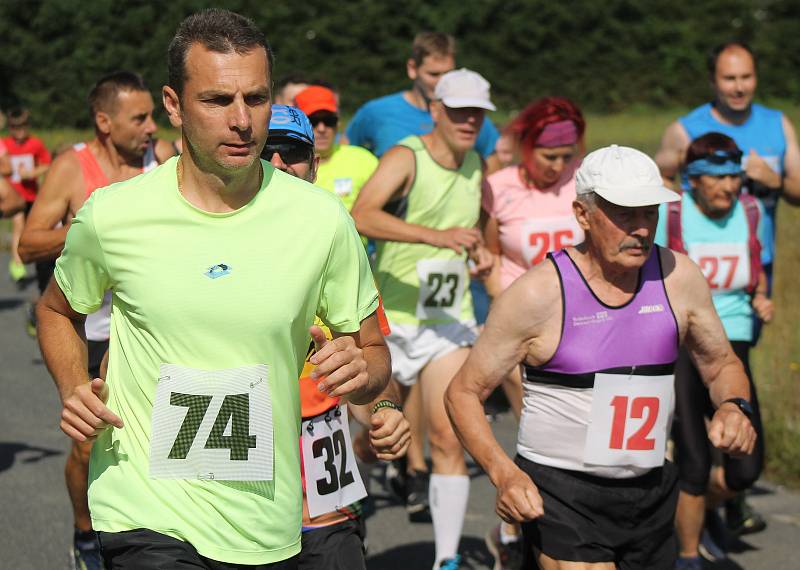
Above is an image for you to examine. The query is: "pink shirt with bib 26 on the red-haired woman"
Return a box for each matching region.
[482,160,583,289]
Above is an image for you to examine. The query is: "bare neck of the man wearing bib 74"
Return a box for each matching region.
[178,149,263,214]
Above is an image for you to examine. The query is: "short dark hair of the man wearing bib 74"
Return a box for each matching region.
[167,8,273,96]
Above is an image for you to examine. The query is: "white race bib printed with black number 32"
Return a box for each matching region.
[300,406,367,518]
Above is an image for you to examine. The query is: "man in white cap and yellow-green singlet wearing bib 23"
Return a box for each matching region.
[352,69,494,569]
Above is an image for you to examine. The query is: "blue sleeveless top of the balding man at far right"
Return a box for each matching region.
[678,103,786,258]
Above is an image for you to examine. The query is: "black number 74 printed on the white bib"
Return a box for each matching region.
[167,392,256,461]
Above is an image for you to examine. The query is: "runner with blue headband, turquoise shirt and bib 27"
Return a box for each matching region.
[656,133,773,569]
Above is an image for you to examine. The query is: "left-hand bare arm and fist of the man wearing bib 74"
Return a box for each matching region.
[36,279,122,442]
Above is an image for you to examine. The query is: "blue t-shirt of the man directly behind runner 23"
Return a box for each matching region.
[347,91,500,158]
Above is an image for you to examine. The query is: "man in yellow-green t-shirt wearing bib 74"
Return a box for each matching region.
[37,10,390,570]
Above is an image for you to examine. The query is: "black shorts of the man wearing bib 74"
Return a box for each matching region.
[97,528,298,570]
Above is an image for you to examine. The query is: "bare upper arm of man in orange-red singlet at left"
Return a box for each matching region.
[19,152,83,263]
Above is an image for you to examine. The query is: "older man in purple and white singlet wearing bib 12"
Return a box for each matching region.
[445,145,755,570]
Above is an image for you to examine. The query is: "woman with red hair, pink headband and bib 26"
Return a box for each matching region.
[482,97,586,568]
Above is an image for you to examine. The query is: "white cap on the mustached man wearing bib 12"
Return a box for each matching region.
[575,144,681,208]
